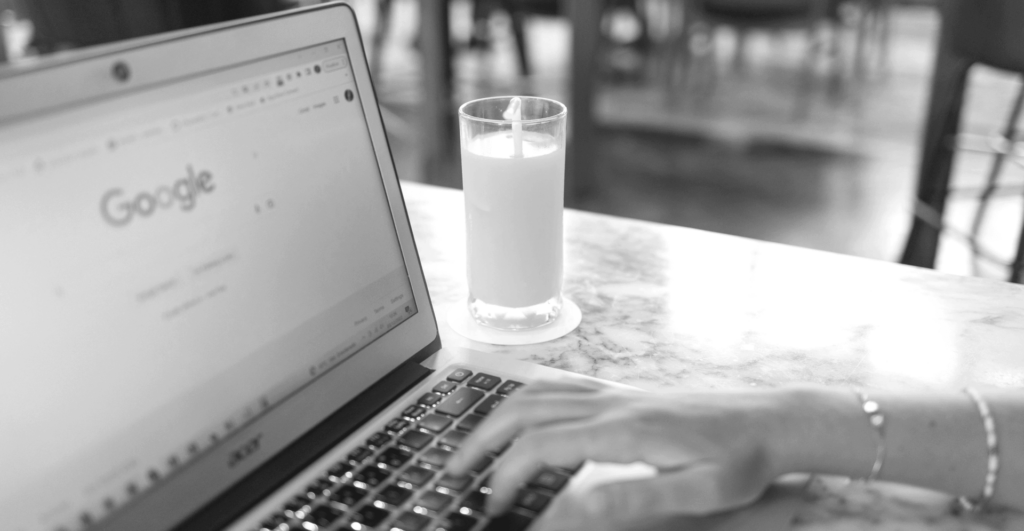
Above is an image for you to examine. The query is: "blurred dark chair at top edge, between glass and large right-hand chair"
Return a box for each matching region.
[666,0,838,115]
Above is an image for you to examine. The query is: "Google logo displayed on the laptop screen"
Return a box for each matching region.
[99,165,215,227]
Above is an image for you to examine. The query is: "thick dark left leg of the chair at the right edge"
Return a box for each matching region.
[900,53,971,268]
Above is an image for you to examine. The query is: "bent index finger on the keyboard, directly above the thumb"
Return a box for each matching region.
[487,418,640,514]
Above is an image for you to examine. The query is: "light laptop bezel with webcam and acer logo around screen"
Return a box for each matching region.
[0,2,440,531]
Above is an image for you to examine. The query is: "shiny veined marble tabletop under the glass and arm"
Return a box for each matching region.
[402,183,1024,531]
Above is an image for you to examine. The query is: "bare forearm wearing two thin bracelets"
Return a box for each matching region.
[771,389,1024,510]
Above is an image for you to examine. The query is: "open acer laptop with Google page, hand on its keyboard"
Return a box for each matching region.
[0,3,802,531]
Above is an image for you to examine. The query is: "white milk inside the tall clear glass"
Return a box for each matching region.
[462,131,565,308]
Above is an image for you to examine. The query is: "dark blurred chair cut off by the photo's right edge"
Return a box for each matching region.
[900,0,1024,282]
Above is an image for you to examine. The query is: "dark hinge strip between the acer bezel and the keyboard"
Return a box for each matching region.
[174,360,430,531]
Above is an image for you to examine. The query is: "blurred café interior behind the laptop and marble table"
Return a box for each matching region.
[0,0,1024,280]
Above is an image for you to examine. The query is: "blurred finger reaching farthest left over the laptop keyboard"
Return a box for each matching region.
[449,393,610,475]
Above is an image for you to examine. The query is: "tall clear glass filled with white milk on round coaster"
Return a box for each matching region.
[459,96,566,330]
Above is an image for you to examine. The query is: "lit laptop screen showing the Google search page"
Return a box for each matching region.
[0,41,417,530]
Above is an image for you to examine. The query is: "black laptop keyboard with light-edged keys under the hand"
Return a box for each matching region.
[258,368,572,531]
